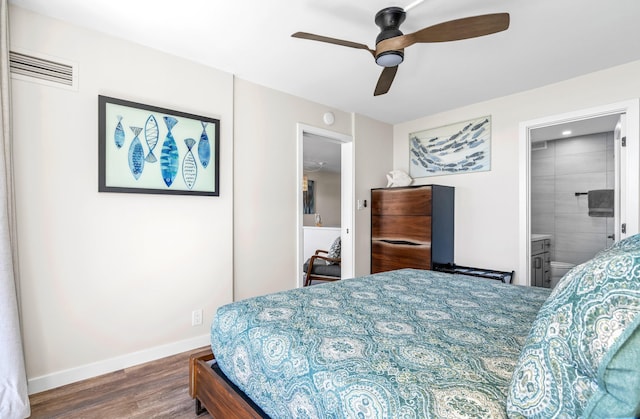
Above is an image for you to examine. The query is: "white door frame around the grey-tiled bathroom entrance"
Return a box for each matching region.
[518,99,640,285]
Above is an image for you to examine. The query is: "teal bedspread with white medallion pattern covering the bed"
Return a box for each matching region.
[211,269,549,418]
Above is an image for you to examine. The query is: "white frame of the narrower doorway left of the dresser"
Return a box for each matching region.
[296,123,355,287]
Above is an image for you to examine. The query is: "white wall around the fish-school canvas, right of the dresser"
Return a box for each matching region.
[394,61,640,284]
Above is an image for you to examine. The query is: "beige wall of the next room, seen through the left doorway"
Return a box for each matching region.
[303,171,342,227]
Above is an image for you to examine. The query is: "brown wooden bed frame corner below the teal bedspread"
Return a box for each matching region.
[189,349,264,419]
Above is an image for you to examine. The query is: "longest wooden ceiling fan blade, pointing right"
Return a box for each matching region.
[376,13,510,54]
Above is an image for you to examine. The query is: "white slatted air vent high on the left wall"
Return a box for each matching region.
[9,51,77,90]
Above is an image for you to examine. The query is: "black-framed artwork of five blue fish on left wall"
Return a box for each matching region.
[98,96,220,196]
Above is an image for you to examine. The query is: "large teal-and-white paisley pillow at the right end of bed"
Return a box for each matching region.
[507,235,640,418]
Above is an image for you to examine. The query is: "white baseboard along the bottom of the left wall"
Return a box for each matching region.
[28,334,210,394]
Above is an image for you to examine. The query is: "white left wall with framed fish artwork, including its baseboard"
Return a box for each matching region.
[10,7,235,392]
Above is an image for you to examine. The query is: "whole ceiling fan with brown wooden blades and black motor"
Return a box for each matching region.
[291,1,509,96]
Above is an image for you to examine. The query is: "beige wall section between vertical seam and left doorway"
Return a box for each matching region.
[234,79,352,300]
